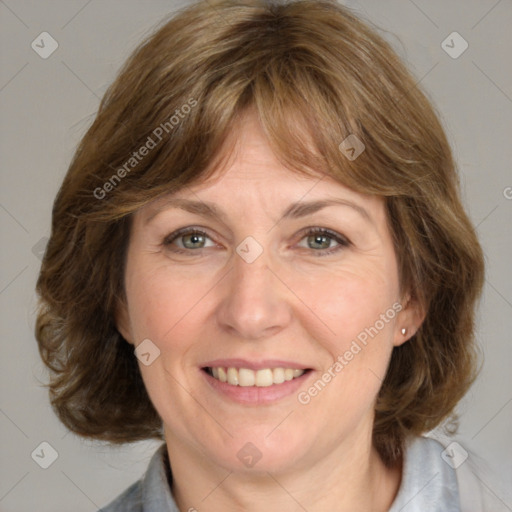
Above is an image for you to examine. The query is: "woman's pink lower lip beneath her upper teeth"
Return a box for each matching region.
[201,370,313,405]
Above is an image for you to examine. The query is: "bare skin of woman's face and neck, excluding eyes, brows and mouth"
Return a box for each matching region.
[118,114,422,512]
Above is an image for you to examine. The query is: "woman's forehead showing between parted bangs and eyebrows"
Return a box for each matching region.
[140,113,383,215]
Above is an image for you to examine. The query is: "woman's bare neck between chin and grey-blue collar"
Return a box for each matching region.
[166,433,401,512]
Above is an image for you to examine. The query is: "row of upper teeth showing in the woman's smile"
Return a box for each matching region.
[210,366,304,387]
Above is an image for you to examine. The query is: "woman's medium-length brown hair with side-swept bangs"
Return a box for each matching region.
[36,0,483,465]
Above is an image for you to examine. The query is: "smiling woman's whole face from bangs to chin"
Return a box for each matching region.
[119,117,416,471]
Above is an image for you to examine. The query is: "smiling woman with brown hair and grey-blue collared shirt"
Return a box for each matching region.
[37,0,492,512]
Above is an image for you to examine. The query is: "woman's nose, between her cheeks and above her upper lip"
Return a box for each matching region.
[217,253,292,340]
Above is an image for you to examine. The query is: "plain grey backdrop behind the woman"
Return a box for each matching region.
[0,0,512,512]
